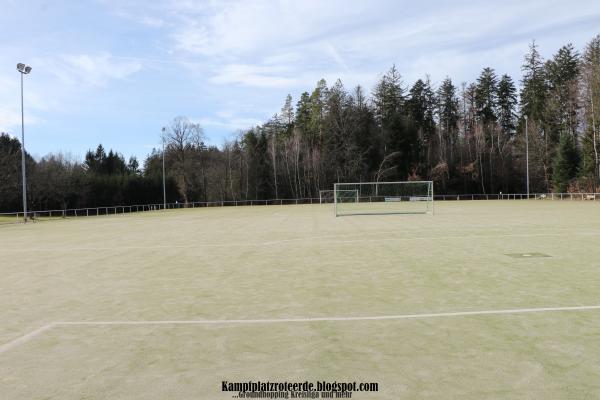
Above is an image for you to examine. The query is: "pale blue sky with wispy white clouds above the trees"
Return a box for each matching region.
[0,0,600,160]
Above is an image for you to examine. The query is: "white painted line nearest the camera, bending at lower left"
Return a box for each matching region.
[0,305,600,354]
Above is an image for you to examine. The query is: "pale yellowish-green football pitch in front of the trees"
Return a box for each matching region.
[0,201,600,400]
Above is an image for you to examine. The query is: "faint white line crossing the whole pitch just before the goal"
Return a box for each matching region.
[0,231,600,253]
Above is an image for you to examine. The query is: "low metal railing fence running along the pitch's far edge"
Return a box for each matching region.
[0,193,600,225]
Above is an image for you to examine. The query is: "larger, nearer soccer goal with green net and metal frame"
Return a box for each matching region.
[333,181,433,217]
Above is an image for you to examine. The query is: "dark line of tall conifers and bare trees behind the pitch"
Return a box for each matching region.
[0,35,600,211]
